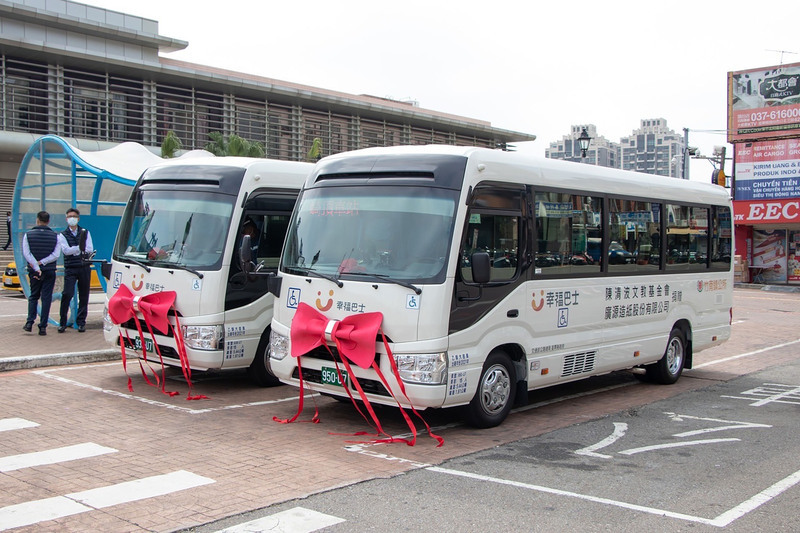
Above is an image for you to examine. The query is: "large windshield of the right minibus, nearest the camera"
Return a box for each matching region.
[281,186,457,283]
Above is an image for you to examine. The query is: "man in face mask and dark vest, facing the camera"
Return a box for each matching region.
[58,207,94,333]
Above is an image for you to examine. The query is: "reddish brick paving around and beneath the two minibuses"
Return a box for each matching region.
[0,290,800,532]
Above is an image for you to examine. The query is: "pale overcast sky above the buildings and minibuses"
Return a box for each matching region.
[82,0,800,180]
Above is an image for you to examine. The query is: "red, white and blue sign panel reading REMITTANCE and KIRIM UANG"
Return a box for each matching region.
[734,138,800,200]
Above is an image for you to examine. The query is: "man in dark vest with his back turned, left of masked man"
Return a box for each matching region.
[22,211,61,335]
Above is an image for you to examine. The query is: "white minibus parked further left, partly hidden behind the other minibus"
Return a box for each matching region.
[104,157,313,386]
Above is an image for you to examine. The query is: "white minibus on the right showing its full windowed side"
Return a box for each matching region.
[269,146,734,427]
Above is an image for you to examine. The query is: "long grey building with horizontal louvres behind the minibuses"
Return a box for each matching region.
[0,0,535,233]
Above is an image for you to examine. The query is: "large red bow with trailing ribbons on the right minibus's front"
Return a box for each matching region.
[274,303,444,447]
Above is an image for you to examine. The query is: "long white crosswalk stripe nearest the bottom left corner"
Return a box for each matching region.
[0,470,214,531]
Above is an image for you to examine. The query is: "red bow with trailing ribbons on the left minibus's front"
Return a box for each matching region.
[108,285,207,400]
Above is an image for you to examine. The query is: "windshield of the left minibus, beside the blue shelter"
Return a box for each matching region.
[114,189,235,270]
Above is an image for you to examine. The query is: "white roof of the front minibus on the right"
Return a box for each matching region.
[322,145,730,205]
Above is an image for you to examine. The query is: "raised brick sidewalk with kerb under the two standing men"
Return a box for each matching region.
[0,289,120,371]
